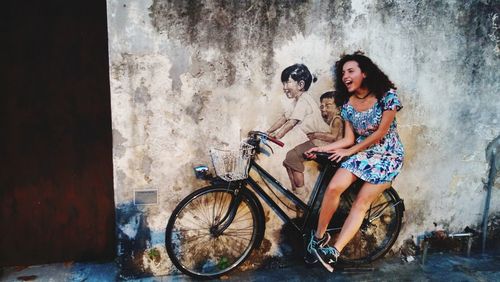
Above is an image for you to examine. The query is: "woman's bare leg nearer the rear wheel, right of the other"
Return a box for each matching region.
[334,183,391,252]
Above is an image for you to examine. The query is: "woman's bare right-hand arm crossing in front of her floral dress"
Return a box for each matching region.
[331,110,396,161]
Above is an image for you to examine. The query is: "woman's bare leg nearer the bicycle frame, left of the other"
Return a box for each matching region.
[315,168,357,238]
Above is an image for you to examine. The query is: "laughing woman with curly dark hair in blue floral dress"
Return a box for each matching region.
[306,52,404,271]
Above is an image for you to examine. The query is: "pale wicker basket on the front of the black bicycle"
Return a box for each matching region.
[210,142,254,181]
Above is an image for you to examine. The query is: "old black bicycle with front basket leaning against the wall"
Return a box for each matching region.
[165,131,405,278]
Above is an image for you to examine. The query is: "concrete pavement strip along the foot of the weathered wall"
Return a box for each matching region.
[0,252,500,282]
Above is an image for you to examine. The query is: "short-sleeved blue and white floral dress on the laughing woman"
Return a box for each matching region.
[341,90,404,184]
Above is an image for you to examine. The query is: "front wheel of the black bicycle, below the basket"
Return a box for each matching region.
[165,183,265,278]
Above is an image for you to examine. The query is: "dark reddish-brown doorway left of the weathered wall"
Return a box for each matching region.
[0,0,116,266]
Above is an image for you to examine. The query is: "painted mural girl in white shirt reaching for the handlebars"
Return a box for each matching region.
[267,64,342,199]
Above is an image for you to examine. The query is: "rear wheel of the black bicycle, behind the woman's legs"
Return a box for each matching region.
[331,187,404,264]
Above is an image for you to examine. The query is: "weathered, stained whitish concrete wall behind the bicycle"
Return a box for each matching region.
[107,0,500,275]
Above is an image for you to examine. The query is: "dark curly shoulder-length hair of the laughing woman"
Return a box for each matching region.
[335,51,396,106]
